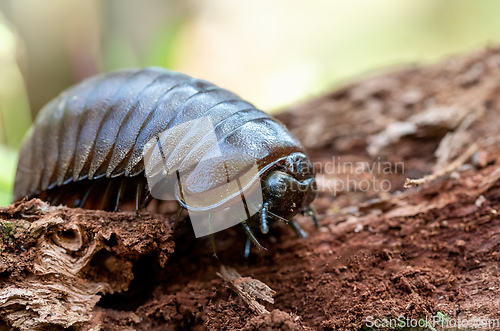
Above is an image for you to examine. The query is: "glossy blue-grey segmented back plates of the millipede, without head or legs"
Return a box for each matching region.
[14,67,303,208]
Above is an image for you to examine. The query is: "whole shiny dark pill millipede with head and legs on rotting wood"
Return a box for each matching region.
[14,68,316,247]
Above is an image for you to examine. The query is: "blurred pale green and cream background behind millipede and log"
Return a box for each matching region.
[0,0,500,206]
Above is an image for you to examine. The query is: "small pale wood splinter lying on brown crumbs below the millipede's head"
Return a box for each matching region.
[217,265,276,314]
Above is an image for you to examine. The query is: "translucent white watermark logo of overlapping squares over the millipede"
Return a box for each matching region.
[143,116,263,237]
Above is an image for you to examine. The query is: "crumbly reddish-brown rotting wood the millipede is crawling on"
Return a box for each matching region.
[0,49,500,330]
